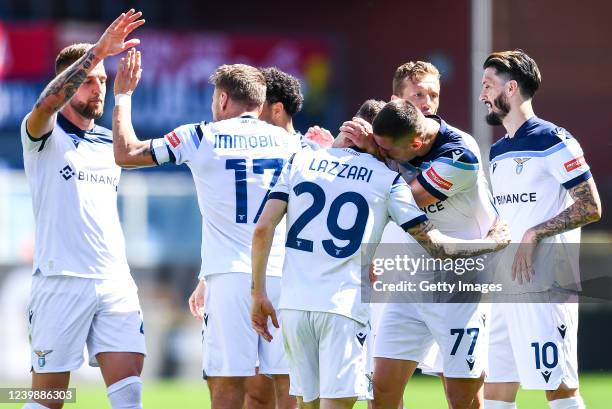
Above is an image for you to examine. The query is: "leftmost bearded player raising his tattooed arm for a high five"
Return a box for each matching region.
[21,10,145,409]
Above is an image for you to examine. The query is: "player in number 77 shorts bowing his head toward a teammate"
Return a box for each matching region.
[366,100,497,408]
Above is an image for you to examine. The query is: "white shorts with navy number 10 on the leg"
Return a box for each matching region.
[486,303,578,390]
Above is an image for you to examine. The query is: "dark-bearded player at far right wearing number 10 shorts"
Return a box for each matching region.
[480,50,601,409]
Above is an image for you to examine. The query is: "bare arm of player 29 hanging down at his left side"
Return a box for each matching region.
[251,199,287,341]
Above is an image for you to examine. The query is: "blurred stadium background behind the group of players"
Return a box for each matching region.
[0,0,612,408]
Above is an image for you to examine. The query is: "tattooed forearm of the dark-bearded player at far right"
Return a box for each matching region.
[531,178,601,241]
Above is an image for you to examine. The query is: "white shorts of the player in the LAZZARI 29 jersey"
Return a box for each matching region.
[281,310,372,402]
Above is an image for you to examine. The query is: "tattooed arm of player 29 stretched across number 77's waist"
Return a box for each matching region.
[407,220,510,258]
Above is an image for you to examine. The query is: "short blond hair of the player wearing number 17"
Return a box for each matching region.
[210,64,266,107]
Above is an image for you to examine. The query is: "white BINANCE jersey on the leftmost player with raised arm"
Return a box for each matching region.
[21,114,129,279]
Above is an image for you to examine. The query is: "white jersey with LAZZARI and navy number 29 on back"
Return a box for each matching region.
[270,148,427,323]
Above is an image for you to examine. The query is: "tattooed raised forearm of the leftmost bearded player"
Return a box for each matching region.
[35,49,97,114]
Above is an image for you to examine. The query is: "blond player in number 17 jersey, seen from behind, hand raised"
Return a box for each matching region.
[113,54,301,409]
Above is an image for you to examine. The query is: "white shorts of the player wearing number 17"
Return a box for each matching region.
[202,273,289,379]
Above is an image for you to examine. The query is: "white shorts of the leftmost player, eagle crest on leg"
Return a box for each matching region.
[28,273,146,373]
